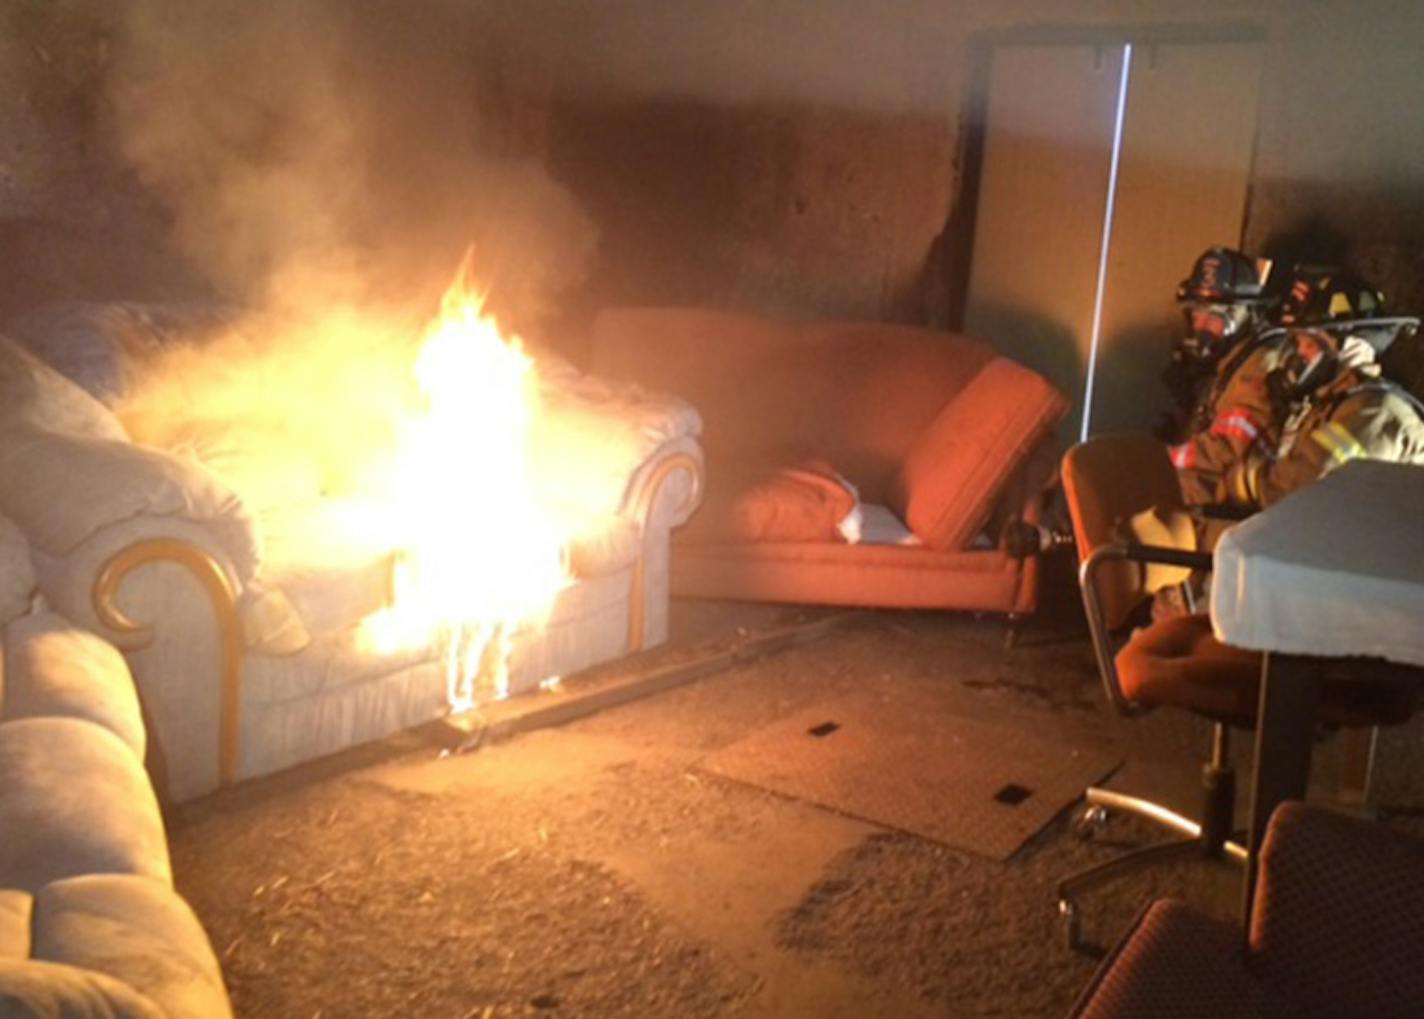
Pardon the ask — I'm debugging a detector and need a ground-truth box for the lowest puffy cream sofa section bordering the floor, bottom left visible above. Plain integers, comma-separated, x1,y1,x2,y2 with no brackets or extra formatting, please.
33,874,232,1019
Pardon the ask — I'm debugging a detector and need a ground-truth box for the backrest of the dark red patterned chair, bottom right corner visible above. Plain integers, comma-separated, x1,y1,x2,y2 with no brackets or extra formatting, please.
1250,803,1424,1016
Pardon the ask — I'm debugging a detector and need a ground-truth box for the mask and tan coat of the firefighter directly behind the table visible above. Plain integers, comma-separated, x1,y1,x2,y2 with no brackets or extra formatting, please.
1216,327,1424,510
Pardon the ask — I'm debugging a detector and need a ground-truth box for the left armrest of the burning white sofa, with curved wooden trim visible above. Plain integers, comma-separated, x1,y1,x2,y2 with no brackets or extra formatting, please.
0,424,261,794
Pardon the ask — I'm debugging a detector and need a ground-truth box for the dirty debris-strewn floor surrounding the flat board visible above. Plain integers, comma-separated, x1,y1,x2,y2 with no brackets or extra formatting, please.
172,580,1424,1019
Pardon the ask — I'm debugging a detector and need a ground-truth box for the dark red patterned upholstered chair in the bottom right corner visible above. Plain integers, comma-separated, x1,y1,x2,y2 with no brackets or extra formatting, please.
1072,803,1424,1019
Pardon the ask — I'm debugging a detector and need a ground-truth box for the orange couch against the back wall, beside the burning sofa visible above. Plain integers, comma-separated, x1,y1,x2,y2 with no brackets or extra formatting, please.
590,309,1068,613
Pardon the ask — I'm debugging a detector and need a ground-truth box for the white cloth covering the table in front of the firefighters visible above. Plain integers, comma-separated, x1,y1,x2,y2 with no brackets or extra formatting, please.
1210,460,1424,666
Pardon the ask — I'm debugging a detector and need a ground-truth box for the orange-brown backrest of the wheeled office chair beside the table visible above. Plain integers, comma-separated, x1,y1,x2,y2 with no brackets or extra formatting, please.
1062,434,1183,630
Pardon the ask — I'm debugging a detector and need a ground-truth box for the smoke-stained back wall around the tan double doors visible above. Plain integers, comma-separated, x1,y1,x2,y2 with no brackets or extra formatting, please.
11,0,1424,335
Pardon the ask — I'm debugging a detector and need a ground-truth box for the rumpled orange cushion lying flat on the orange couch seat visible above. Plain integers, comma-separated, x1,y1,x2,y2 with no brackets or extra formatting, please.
678,461,857,544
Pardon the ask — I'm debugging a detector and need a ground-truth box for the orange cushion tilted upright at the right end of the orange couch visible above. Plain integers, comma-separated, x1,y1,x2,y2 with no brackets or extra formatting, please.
887,357,1068,551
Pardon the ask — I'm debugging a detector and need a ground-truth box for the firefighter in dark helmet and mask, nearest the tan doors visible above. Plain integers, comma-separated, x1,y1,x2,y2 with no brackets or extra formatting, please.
1162,248,1270,441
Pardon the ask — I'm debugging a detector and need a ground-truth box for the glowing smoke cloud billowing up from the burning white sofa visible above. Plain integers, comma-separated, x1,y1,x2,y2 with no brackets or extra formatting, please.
86,0,597,504
